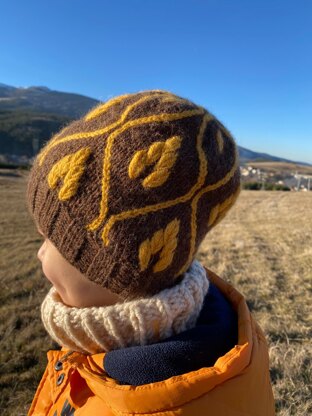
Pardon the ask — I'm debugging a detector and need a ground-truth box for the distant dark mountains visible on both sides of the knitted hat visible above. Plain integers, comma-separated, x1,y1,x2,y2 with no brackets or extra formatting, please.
0,83,309,166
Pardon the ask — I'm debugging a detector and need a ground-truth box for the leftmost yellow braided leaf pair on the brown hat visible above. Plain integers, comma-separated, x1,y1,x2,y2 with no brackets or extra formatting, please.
48,147,91,201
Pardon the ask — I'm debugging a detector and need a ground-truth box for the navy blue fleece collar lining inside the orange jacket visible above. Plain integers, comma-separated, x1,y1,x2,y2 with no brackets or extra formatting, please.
104,283,238,386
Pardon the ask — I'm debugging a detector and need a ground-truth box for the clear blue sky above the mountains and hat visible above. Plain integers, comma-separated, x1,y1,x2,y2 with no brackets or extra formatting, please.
0,0,312,163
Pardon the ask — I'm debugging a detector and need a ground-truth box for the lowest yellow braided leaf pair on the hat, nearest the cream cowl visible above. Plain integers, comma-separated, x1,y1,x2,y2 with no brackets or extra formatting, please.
139,218,180,273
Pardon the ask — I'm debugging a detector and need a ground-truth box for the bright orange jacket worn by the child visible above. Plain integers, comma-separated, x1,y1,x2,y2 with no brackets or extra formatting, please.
28,270,275,416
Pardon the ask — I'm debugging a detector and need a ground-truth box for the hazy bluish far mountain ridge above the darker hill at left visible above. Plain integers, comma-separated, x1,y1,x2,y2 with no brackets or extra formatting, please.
0,84,99,118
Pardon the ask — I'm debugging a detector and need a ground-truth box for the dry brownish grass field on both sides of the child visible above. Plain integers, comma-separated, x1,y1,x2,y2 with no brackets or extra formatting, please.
0,176,312,416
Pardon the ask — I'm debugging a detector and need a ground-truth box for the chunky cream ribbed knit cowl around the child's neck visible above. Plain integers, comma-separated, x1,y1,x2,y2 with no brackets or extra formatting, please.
41,260,209,354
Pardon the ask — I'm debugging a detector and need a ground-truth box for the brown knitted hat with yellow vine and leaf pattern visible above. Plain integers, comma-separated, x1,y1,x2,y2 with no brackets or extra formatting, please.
27,91,240,299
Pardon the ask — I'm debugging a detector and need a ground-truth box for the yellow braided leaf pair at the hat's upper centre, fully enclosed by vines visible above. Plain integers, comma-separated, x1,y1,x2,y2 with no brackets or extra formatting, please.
128,136,182,188
